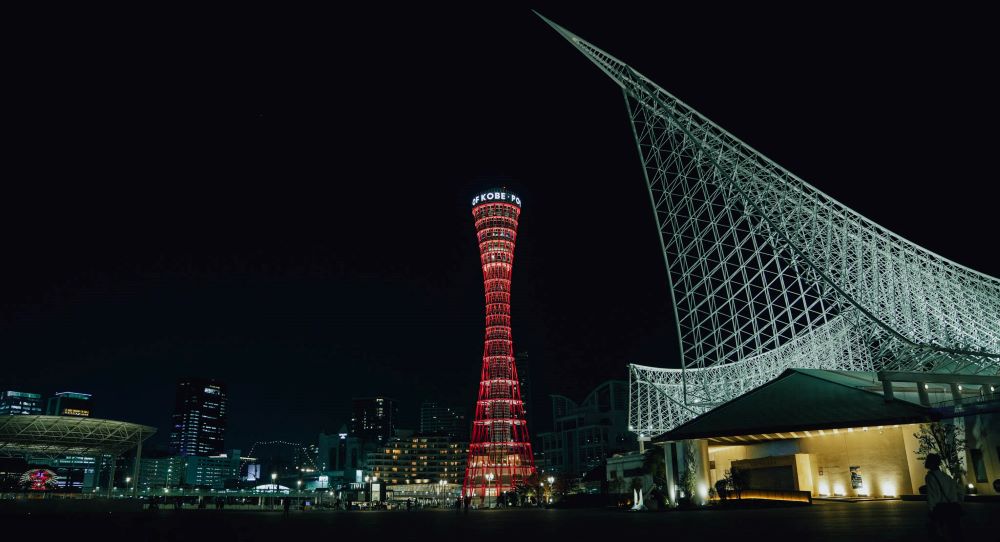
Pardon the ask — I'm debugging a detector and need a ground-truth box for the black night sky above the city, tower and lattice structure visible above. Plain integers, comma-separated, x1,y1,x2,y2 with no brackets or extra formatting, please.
0,4,1000,449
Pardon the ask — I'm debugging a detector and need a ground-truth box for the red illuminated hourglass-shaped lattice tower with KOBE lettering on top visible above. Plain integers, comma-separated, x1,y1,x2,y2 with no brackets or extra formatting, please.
462,190,535,502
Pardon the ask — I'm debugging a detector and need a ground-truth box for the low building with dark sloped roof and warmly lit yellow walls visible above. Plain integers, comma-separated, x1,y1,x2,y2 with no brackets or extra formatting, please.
654,369,1000,501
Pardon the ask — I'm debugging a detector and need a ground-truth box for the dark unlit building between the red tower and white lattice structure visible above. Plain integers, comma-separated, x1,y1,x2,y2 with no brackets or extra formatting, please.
539,380,638,477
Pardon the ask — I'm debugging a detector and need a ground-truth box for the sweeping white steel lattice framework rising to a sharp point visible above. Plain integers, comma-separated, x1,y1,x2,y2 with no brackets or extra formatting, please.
543,13,1000,435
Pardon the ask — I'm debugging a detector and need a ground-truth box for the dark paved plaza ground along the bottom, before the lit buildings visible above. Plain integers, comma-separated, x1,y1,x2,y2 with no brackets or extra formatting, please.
0,501,1000,542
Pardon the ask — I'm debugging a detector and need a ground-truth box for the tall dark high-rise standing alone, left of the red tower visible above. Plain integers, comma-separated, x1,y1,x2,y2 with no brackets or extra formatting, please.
170,378,226,456
